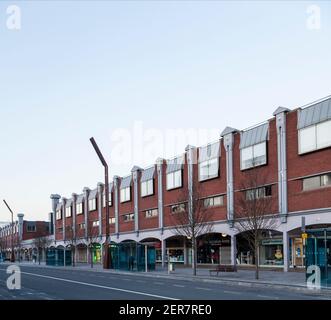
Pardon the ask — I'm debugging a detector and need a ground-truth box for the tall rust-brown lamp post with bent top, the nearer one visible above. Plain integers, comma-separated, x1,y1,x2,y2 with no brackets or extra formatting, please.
90,137,111,269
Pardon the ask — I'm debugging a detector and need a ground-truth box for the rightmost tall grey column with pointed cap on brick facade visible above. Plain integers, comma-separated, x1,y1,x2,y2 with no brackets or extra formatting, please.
273,107,289,223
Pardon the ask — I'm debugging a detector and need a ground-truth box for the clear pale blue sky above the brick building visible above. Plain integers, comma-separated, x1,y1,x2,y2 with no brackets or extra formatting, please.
0,0,331,221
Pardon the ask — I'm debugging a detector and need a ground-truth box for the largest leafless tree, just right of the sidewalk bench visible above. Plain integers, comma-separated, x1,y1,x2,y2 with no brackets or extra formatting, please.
234,168,278,279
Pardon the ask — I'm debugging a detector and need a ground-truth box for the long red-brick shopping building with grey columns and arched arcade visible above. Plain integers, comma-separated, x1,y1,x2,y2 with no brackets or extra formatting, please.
21,94,331,271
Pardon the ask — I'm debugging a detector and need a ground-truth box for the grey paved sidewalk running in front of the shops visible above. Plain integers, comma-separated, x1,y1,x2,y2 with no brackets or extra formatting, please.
10,262,307,289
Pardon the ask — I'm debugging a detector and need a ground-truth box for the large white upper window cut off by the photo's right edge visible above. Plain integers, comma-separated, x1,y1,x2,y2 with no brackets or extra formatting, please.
298,120,331,154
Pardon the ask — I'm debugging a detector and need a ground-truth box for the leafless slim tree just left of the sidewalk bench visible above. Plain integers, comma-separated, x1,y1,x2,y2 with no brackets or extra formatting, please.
168,185,214,276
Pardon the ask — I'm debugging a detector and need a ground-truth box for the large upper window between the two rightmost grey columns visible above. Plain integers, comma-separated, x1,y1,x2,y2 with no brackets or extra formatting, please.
240,142,267,170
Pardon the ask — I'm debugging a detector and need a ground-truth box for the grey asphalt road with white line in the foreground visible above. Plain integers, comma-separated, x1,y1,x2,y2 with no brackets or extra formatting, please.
0,265,331,300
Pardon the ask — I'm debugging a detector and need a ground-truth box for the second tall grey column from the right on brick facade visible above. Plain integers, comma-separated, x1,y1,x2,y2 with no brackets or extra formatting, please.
221,127,238,226
